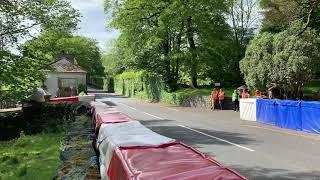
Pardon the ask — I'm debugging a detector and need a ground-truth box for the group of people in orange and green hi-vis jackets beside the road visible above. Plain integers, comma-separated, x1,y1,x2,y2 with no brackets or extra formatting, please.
211,88,267,111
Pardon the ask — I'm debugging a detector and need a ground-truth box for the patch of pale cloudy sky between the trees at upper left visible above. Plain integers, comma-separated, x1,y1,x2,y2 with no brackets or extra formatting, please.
71,0,119,49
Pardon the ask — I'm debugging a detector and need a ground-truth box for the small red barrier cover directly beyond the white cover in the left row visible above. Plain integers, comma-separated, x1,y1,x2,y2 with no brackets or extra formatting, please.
96,111,132,128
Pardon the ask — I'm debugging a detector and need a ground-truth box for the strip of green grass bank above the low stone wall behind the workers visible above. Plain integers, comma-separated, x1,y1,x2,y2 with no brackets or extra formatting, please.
175,88,234,97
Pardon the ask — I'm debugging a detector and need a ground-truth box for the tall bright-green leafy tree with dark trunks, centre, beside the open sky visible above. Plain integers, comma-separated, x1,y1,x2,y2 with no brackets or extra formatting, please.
106,0,232,90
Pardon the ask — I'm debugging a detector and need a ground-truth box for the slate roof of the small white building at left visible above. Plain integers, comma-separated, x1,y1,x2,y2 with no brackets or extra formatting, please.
49,56,87,73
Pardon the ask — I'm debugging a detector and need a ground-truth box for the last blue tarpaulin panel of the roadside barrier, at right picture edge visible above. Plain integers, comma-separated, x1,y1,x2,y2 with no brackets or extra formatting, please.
301,102,320,134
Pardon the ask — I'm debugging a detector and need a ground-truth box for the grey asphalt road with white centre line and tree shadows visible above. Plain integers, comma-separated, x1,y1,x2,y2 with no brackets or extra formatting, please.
97,95,320,180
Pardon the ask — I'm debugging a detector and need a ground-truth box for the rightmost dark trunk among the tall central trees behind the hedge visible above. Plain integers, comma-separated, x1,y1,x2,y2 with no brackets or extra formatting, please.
187,16,198,88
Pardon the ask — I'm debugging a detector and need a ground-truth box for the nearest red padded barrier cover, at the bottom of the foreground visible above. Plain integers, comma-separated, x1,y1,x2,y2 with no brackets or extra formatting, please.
107,143,246,180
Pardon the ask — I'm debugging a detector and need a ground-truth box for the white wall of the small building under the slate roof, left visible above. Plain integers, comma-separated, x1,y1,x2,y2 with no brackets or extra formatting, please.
44,72,87,97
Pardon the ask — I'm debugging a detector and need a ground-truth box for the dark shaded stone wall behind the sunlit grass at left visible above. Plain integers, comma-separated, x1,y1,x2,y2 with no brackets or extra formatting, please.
0,102,90,141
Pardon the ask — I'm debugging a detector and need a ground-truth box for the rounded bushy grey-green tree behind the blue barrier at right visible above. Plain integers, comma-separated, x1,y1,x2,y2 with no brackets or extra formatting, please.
240,22,320,97
